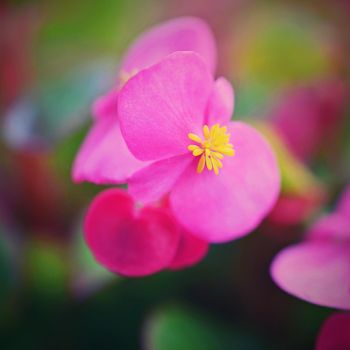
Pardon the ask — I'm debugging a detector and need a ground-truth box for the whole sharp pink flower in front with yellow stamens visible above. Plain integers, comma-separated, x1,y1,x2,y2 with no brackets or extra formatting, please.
118,52,280,242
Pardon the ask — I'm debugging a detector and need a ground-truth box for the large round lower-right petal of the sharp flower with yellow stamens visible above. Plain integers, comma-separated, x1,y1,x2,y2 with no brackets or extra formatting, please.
170,122,280,242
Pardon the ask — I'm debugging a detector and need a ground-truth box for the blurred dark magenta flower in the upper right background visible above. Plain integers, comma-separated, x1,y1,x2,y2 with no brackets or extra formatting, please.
272,80,345,160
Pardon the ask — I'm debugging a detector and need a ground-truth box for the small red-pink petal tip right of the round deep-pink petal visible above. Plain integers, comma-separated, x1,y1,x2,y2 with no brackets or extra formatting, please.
169,230,209,270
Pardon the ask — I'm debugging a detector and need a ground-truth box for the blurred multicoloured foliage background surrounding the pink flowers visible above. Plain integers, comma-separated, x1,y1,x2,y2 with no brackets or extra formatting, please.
0,0,350,350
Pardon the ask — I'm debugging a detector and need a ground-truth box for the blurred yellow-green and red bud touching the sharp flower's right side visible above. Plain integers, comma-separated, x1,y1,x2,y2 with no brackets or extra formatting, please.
255,122,326,226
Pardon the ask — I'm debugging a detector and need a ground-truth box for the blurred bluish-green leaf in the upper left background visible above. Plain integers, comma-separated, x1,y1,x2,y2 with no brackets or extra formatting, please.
2,62,114,150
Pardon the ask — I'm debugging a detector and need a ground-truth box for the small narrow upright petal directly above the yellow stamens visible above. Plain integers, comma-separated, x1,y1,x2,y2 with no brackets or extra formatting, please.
206,77,234,125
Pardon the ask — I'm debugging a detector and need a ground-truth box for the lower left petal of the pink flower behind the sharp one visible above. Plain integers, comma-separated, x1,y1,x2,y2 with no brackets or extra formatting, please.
73,117,147,184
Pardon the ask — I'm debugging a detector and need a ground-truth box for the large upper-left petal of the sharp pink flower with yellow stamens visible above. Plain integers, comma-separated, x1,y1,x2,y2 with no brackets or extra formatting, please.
118,52,213,160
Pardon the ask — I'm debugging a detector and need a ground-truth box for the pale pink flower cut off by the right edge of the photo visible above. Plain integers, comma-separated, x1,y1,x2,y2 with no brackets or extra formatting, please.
271,187,350,309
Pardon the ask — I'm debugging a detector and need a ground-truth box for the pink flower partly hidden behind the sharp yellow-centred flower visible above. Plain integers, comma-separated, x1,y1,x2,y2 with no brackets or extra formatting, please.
72,17,216,184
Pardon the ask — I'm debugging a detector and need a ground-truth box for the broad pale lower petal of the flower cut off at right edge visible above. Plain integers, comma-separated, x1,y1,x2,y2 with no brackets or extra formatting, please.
271,241,350,309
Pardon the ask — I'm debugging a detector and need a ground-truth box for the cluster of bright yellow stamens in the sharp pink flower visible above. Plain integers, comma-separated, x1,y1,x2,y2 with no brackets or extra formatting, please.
187,124,235,175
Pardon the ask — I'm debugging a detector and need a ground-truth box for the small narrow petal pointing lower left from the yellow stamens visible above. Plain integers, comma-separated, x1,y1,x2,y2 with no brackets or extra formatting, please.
128,154,193,204
